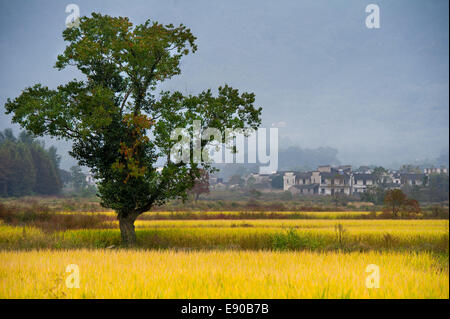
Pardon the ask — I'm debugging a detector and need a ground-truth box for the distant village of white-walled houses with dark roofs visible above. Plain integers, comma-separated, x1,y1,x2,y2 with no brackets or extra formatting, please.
210,165,448,195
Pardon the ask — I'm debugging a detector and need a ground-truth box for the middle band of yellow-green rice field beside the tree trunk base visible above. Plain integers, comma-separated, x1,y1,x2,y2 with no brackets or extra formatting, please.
0,220,449,254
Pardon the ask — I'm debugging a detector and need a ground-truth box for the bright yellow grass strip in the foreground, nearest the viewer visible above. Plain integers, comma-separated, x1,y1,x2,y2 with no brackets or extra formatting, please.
0,249,449,298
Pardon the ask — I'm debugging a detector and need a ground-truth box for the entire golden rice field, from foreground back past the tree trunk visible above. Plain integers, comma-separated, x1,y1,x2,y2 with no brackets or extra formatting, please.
0,212,449,298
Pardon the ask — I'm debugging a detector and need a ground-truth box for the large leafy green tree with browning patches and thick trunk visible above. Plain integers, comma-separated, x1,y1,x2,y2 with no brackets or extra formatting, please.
5,13,261,245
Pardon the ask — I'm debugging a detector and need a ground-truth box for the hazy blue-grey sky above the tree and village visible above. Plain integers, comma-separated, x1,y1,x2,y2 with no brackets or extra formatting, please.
0,0,449,169
